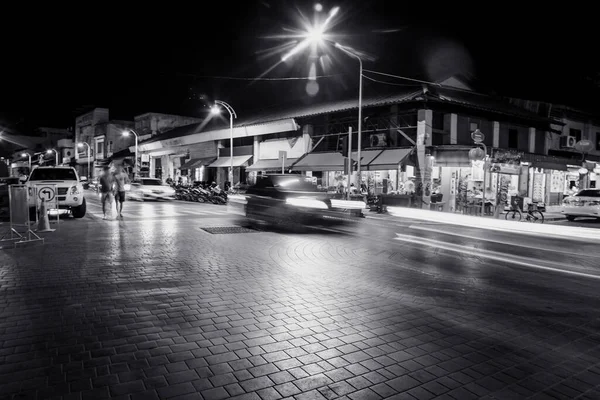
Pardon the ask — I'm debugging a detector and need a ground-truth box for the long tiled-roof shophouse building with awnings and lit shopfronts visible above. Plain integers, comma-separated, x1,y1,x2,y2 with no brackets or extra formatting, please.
134,78,554,216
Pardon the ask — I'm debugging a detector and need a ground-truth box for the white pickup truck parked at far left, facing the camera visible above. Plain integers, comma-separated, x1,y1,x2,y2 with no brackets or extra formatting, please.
27,166,86,218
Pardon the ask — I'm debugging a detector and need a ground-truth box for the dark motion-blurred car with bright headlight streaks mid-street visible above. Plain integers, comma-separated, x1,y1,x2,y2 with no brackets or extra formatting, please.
241,175,365,225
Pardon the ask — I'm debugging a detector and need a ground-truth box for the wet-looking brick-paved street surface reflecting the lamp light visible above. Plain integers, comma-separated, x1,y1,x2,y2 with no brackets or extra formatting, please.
0,192,600,400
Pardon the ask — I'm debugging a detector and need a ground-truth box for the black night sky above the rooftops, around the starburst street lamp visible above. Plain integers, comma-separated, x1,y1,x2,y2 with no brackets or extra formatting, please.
0,0,600,133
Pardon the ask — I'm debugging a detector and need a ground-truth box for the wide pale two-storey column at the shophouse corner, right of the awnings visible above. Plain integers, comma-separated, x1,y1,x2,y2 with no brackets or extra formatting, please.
415,110,433,208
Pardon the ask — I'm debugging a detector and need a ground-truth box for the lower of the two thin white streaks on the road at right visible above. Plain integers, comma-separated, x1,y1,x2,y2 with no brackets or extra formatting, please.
396,233,600,280
